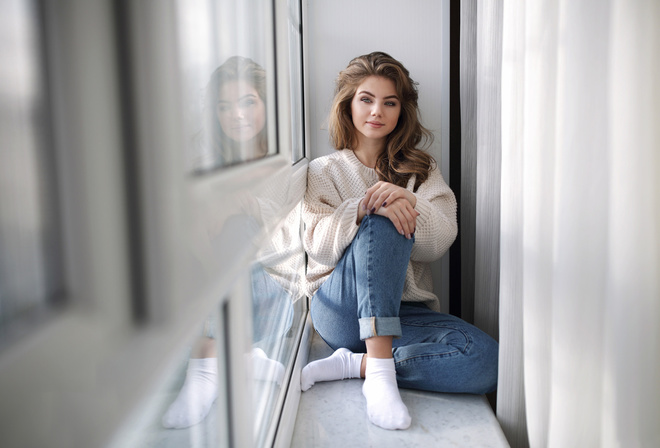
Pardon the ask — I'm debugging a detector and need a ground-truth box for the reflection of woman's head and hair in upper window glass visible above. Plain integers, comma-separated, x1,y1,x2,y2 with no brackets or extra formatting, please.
193,56,268,172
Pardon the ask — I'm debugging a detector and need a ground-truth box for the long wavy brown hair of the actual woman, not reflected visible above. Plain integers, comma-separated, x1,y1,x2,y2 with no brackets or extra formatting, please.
328,51,435,190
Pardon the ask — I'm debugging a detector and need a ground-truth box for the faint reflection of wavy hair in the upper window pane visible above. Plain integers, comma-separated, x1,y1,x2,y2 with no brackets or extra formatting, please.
204,56,268,165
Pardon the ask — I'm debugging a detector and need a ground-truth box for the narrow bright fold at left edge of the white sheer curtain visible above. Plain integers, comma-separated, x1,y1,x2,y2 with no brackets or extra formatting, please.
497,0,538,448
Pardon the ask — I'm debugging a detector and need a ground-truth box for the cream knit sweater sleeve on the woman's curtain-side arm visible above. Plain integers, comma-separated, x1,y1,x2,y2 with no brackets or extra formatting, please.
410,168,458,262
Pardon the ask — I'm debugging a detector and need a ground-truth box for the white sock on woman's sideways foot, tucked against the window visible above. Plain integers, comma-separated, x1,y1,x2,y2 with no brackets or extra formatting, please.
300,348,364,391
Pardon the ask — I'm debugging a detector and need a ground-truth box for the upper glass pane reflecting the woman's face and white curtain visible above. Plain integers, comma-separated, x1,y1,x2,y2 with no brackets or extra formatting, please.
177,0,277,173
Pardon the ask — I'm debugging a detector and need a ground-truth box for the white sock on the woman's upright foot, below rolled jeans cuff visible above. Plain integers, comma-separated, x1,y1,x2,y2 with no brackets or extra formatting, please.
362,358,411,429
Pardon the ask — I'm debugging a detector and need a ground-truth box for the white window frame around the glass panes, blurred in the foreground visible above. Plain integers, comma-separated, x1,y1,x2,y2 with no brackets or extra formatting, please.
0,0,307,447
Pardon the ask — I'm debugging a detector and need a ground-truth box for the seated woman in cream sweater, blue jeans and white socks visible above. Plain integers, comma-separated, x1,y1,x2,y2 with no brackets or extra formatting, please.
301,52,498,429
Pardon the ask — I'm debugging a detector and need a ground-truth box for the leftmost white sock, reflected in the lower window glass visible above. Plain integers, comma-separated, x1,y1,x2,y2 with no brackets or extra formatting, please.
162,358,218,429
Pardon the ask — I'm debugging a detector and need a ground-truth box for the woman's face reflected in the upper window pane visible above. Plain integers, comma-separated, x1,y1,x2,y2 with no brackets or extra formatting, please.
216,80,266,143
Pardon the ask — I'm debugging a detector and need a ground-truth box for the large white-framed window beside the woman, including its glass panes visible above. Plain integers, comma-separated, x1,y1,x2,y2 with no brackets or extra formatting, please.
0,0,307,447
